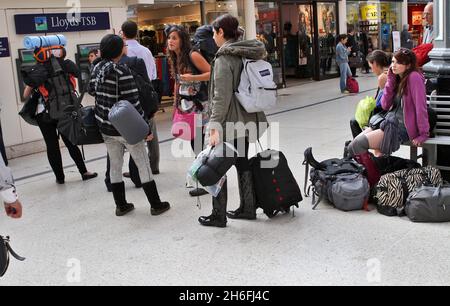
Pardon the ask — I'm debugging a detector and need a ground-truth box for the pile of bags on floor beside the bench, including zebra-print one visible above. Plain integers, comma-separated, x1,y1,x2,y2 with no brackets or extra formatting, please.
303,148,450,222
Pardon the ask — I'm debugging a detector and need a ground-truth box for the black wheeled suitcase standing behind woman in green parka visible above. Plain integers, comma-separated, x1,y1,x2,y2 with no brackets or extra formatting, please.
250,150,303,218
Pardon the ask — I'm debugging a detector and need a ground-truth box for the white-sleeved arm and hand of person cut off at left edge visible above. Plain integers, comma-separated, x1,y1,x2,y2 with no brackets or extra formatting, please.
0,155,22,219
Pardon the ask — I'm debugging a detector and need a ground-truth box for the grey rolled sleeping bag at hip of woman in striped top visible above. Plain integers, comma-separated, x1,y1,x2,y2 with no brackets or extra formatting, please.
108,100,150,145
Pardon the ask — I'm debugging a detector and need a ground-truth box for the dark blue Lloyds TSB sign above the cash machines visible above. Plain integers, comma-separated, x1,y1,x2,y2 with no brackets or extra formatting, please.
14,12,111,34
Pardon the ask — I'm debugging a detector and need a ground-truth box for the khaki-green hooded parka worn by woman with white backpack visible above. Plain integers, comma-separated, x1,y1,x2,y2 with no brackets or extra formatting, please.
206,39,268,143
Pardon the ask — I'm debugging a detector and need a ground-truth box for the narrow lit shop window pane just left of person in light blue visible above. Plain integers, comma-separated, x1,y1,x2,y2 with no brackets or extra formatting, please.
317,3,337,76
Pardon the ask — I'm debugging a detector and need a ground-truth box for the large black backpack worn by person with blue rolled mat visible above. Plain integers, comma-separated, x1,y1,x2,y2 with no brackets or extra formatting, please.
45,56,80,120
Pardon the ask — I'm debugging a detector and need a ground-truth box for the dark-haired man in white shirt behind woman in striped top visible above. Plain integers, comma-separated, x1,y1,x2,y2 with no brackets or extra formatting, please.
120,21,160,177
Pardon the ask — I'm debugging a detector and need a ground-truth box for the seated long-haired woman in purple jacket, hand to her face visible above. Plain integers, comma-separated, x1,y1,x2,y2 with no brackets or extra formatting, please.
347,48,430,156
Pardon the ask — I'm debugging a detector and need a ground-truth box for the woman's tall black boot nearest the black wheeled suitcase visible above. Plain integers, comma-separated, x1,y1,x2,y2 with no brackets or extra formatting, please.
227,171,256,220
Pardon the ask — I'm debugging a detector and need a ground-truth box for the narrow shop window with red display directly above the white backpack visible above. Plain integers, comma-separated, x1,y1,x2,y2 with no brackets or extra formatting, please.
255,2,283,84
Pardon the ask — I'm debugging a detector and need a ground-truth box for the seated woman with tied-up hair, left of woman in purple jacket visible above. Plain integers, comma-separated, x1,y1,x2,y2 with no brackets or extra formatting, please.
350,50,390,138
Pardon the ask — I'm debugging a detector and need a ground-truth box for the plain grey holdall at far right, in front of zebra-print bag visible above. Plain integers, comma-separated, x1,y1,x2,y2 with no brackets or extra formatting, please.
405,185,450,222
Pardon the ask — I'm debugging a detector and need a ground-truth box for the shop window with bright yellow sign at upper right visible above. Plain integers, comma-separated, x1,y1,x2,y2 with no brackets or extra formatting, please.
347,1,402,53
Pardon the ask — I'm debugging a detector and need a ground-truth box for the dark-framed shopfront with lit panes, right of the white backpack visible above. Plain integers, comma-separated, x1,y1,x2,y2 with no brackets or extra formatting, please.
281,1,338,80
